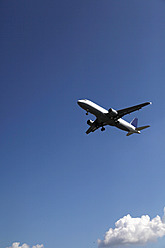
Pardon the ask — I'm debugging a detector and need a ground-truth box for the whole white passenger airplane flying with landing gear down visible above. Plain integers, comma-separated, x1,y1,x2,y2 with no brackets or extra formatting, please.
77,99,152,136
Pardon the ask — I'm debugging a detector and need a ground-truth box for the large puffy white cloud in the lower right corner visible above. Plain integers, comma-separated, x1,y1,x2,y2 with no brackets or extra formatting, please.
98,208,165,247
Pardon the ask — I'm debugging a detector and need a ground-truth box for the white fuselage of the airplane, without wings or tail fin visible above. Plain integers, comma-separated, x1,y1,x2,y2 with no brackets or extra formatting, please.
78,99,140,133
